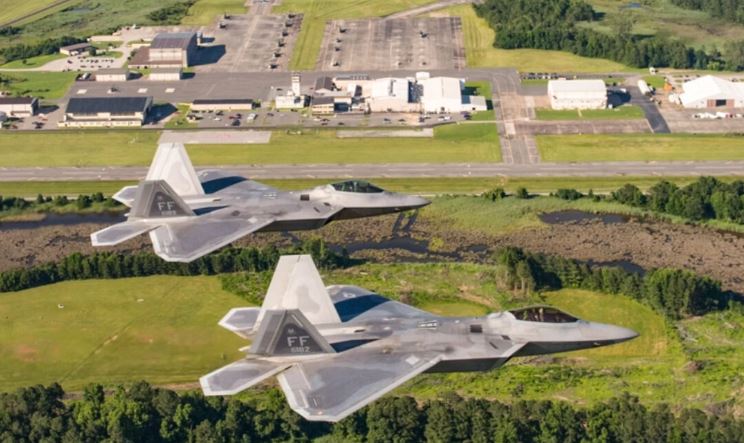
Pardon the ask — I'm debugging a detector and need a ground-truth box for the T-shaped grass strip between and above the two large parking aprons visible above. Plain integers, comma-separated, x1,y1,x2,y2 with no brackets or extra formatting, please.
273,0,436,71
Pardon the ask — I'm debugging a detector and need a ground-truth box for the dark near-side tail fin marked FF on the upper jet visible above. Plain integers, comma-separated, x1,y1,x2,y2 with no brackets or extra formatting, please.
129,180,194,218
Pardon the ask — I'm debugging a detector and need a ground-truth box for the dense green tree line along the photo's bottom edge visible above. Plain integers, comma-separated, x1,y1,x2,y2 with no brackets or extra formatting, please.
0,382,744,443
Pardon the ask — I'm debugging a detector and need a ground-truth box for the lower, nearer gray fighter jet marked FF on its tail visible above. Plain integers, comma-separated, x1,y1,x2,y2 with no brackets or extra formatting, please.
200,255,638,421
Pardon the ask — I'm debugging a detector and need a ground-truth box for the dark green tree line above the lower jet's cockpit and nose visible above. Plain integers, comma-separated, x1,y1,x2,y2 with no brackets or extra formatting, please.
495,247,740,320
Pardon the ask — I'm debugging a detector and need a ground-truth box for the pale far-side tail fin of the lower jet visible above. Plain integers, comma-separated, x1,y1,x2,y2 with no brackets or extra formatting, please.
256,255,341,327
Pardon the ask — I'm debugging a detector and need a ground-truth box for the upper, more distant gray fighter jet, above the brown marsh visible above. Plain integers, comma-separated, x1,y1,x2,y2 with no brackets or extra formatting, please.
91,143,429,262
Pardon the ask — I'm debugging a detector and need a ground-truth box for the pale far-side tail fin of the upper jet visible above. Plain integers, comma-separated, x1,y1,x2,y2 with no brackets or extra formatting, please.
145,143,204,195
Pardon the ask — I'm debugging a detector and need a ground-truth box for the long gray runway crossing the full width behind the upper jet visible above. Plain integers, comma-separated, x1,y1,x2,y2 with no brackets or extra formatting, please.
5,161,744,181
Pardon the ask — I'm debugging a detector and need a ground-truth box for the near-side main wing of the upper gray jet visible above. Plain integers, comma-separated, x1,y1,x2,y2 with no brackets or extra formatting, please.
150,213,274,262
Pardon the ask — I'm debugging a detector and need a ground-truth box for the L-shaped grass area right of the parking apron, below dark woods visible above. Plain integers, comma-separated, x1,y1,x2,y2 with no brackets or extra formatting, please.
442,5,631,72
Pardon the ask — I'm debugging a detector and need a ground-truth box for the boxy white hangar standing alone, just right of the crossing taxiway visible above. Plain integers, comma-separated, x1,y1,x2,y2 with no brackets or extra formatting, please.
548,79,607,109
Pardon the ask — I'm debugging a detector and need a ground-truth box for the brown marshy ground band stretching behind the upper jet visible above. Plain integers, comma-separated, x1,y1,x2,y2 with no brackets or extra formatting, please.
0,215,744,293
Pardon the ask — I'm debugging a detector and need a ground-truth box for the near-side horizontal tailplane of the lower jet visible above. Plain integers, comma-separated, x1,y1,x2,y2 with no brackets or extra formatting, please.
199,360,291,395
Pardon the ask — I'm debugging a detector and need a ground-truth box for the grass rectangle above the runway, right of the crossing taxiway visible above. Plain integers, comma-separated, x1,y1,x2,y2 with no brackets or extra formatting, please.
537,134,744,162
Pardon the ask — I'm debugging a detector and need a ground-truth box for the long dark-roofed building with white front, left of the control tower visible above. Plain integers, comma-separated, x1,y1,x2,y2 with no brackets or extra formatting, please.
59,97,152,128
